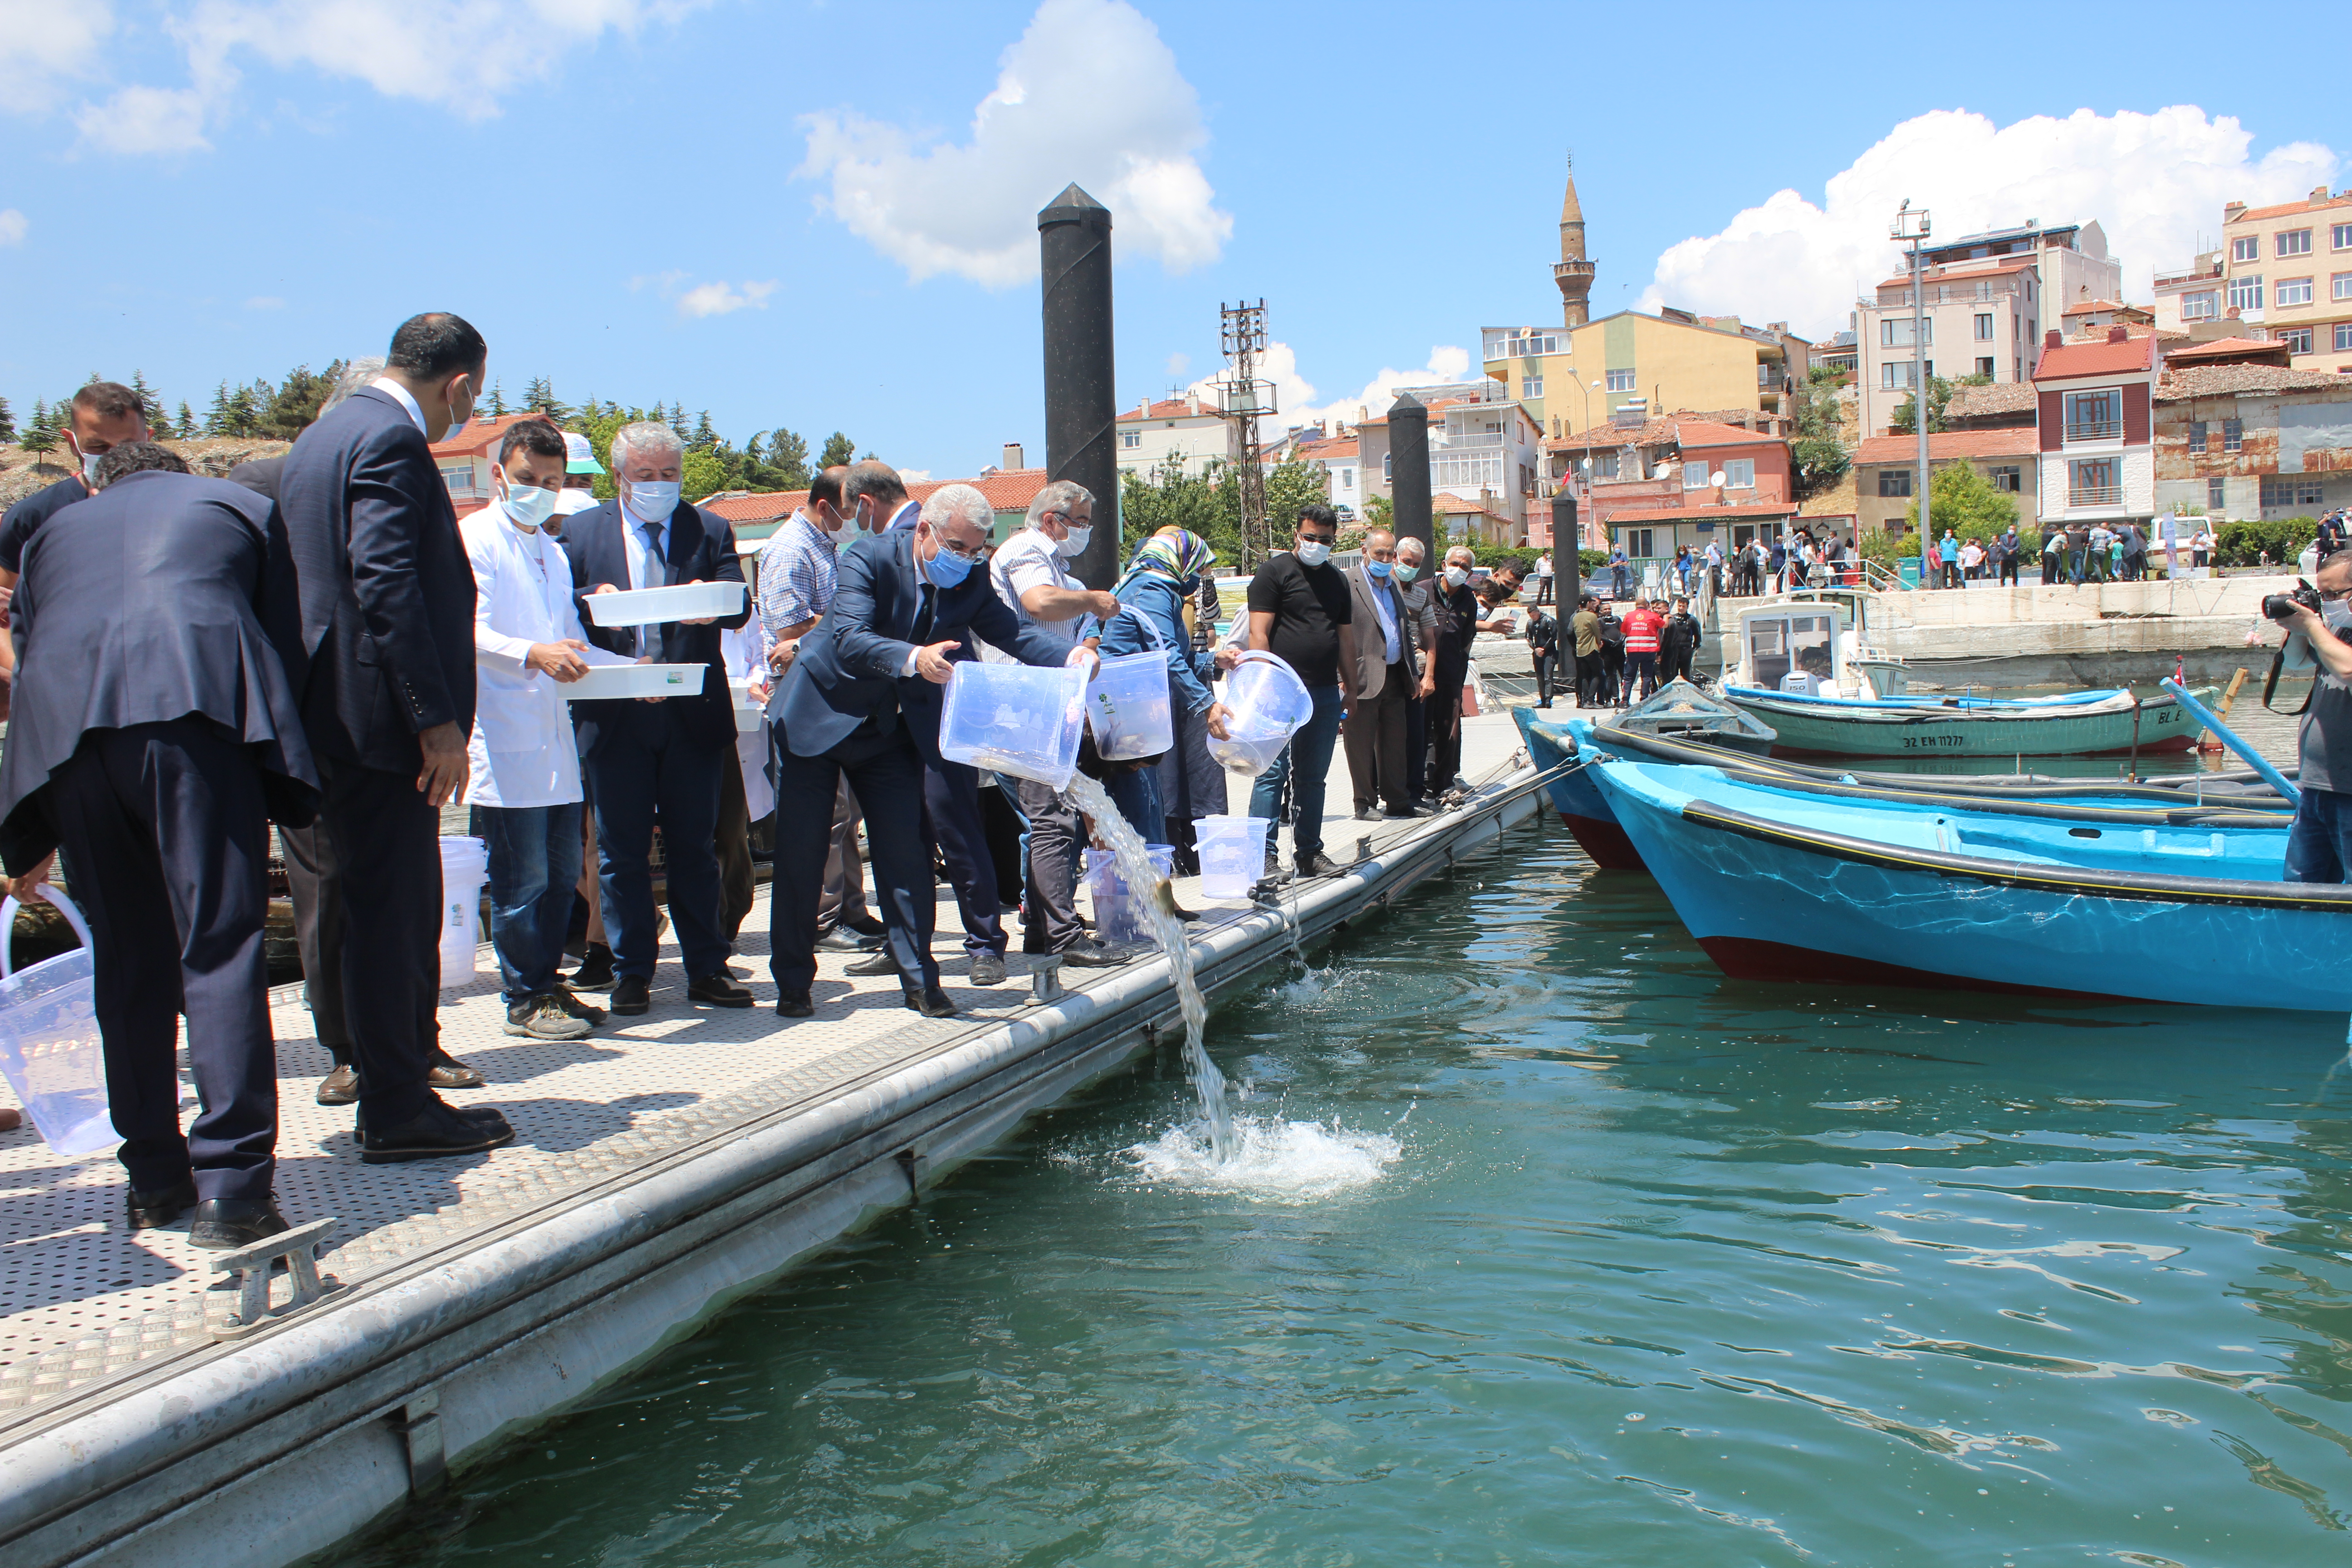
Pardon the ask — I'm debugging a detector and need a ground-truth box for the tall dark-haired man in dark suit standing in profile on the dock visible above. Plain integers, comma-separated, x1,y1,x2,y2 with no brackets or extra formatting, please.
278,313,515,1164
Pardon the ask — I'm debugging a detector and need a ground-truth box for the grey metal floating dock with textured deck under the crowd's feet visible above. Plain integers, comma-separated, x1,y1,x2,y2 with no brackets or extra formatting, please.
0,712,1541,1568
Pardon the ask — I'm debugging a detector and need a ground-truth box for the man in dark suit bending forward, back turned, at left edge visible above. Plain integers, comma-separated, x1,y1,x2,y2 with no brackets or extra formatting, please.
0,442,318,1248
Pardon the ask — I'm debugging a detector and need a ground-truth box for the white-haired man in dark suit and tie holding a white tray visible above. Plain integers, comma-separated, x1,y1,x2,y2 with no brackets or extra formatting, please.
564,421,752,1013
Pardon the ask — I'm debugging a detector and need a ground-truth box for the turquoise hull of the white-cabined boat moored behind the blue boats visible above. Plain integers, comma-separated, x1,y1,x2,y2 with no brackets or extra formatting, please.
1731,694,2201,757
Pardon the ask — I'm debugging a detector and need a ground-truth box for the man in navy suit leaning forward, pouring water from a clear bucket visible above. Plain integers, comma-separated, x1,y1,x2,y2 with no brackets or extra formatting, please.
767,484,1091,1018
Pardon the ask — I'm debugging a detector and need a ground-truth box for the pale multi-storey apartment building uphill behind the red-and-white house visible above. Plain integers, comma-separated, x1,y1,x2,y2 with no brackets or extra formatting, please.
1856,221,2124,435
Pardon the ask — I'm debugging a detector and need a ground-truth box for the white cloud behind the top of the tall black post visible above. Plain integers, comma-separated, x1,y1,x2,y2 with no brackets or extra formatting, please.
797,0,1232,289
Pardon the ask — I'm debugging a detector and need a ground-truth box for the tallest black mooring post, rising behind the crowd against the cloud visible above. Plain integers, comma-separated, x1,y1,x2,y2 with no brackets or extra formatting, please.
1037,186,1124,588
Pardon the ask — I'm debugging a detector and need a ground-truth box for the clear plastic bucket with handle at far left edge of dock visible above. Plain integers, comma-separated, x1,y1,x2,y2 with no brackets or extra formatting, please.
0,886,122,1159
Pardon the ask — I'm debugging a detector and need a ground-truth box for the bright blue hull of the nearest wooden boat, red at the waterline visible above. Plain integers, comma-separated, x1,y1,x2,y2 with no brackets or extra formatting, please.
1590,764,2352,1011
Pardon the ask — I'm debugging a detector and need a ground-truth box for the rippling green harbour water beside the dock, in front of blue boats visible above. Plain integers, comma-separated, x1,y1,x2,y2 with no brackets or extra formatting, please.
355,828,2352,1568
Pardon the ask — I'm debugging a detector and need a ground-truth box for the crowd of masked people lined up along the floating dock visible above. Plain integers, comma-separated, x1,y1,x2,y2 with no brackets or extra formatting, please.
0,313,1548,1248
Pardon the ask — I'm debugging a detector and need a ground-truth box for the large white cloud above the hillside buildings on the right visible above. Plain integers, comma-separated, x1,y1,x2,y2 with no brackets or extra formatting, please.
1637,103,2340,334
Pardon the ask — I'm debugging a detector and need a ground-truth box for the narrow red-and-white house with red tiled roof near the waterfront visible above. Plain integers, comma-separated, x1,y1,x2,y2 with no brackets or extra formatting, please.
2032,324,2159,529
